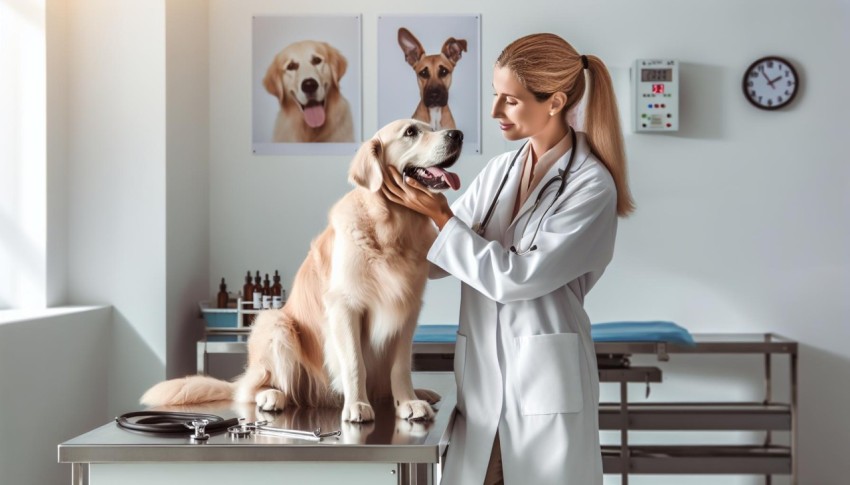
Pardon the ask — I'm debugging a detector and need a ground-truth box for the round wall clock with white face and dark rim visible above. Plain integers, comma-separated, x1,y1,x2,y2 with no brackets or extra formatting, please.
744,56,798,110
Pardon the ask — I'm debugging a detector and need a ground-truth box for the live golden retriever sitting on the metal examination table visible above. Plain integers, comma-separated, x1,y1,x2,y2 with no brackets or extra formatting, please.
141,119,463,422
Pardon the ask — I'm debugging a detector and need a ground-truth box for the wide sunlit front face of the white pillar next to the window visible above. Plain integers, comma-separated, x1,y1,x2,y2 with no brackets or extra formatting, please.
66,0,167,414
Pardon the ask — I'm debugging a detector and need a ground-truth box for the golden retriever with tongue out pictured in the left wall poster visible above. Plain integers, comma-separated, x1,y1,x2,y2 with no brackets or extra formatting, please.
263,40,354,143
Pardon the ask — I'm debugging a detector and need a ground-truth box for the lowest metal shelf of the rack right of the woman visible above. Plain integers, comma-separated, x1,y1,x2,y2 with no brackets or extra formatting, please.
602,445,792,475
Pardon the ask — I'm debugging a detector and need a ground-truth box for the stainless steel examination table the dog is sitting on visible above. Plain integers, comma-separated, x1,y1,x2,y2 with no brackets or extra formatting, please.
59,372,456,485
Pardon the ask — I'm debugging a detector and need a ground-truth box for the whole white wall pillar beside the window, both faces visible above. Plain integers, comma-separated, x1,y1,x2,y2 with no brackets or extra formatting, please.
61,0,209,412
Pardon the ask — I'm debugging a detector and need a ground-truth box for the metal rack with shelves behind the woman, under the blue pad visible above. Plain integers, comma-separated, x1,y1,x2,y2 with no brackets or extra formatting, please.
414,333,798,485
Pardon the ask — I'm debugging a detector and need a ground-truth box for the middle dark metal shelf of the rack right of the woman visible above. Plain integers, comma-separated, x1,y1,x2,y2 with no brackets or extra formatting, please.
599,402,791,431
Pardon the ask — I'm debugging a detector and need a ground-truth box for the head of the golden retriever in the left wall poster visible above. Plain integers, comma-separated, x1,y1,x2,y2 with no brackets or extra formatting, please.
263,40,348,128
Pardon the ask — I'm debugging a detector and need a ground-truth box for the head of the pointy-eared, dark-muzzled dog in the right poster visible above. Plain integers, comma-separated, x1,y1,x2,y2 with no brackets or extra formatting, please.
398,27,466,108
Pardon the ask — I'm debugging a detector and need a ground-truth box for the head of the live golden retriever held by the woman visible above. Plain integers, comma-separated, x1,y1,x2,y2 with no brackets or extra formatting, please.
348,120,463,192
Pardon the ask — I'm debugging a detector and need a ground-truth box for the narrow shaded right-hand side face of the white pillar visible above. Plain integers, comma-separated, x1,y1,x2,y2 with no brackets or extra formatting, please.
165,0,210,377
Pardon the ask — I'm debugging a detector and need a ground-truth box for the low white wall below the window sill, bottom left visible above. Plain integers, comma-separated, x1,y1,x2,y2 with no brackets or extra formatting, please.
0,307,112,485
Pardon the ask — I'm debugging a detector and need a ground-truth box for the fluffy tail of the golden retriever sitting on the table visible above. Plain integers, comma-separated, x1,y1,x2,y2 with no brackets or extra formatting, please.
139,376,234,406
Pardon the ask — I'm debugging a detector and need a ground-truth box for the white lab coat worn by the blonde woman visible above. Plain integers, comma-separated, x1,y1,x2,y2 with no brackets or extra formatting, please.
428,133,617,485
